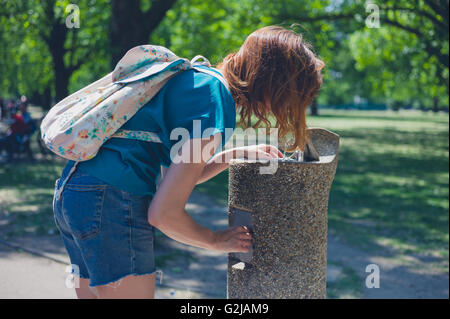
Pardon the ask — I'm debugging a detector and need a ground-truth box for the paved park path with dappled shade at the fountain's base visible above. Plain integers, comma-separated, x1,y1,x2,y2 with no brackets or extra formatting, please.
0,192,449,298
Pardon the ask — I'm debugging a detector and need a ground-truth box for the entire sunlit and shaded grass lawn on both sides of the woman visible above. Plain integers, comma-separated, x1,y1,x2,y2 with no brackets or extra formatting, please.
0,110,449,258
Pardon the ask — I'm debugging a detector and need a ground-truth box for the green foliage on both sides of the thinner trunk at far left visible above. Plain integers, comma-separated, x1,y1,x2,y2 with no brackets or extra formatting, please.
0,0,109,102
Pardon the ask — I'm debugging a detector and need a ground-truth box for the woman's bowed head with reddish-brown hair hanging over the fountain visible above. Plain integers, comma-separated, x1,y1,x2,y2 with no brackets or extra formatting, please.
219,26,324,150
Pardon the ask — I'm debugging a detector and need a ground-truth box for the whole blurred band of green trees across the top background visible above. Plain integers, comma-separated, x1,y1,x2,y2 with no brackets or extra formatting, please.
0,0,449,111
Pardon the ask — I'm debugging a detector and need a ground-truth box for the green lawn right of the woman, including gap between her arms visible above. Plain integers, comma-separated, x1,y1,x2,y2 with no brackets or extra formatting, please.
196,110,449,258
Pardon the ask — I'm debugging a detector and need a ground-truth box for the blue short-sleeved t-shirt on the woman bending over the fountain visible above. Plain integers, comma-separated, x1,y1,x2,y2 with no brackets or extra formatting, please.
67,66,236,196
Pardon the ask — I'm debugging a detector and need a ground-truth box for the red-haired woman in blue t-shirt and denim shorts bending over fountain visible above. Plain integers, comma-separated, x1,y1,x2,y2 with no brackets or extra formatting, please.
53,26,324,298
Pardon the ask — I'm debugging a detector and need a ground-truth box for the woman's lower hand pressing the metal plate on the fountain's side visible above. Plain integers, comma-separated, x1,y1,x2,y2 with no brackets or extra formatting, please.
211,226,252,253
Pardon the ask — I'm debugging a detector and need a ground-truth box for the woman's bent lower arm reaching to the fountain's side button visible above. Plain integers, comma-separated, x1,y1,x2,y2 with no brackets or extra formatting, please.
148,133,251,252
